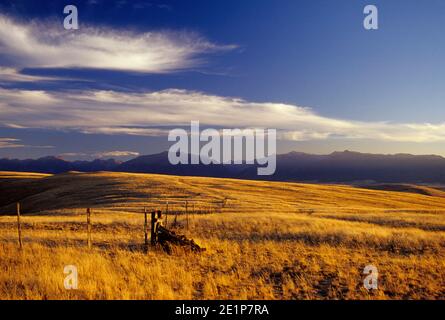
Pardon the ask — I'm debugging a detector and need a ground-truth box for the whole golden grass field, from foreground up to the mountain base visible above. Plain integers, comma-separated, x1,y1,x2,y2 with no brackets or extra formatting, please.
0,172,445,299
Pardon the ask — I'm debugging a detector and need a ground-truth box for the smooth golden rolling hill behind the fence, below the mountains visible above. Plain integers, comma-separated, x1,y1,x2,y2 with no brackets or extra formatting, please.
0,172,445,214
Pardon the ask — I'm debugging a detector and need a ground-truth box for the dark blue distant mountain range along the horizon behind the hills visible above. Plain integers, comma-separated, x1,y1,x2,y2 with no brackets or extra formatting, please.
0,151,445,183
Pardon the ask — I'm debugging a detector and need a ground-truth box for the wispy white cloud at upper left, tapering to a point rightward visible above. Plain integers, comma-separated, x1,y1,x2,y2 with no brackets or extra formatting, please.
0,15,236,73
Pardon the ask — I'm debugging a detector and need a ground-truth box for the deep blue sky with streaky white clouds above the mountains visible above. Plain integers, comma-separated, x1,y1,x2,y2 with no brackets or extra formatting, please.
0,0,445,159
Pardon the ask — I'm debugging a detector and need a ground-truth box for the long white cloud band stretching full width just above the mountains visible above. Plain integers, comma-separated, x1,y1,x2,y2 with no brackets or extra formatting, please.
0,89,445,142
